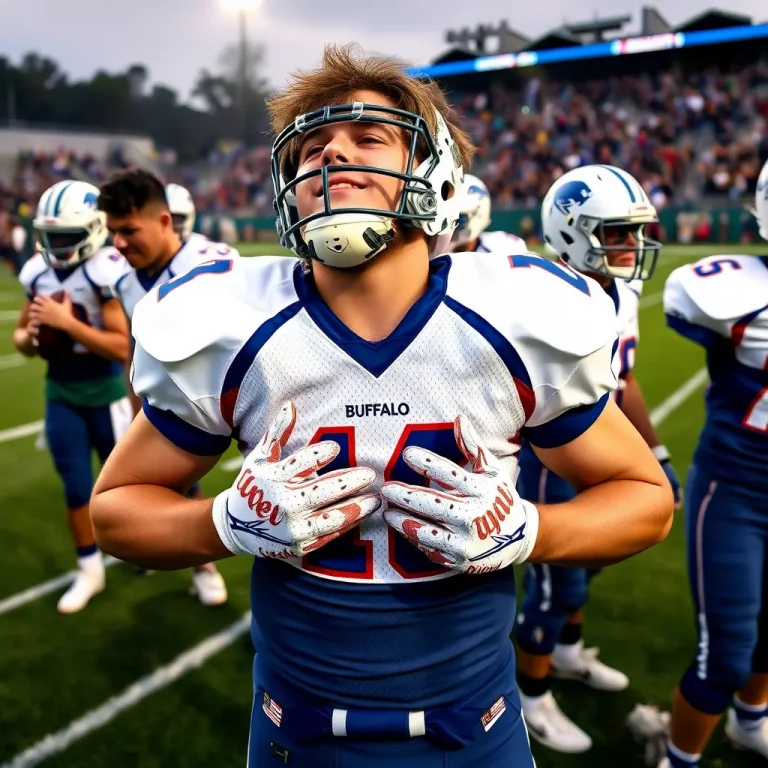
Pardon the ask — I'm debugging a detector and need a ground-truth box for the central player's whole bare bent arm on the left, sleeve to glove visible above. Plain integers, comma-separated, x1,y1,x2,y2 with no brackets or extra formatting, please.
90,413,232,570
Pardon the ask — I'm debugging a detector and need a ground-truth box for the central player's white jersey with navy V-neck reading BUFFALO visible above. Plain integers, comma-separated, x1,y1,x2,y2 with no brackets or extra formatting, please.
132,253,618,583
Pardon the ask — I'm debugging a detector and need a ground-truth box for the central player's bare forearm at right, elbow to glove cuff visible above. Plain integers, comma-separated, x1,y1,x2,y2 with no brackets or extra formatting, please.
530,474,673,568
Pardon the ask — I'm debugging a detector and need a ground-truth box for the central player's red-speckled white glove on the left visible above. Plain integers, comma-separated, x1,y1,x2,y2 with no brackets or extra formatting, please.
213,403,382,560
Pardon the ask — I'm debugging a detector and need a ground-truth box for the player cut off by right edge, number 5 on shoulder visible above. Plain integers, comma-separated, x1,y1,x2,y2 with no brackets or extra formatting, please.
662,163,768,768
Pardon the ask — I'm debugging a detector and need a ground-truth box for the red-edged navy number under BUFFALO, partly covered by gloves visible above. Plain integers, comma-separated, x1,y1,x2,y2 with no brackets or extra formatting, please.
302,422,466,579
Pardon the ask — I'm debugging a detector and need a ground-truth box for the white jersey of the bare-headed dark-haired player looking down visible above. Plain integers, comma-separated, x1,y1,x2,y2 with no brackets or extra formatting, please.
113,234,240,320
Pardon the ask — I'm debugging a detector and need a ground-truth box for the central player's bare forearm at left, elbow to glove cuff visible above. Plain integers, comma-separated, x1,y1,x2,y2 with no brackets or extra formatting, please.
90,485,232,570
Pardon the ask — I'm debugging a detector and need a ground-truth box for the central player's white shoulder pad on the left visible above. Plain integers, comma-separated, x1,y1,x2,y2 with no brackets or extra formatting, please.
132,257,297,363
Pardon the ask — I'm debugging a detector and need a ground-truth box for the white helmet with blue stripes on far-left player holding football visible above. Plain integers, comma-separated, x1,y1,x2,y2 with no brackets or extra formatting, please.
32,180,109,269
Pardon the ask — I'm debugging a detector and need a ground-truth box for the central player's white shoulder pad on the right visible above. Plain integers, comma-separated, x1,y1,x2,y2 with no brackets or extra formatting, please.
448,253,616,357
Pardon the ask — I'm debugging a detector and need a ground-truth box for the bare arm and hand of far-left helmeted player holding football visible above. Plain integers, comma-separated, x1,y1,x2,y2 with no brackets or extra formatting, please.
30,296,129,363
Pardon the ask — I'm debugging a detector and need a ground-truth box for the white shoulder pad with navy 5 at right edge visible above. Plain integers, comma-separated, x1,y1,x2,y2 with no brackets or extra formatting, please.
665,255,768,321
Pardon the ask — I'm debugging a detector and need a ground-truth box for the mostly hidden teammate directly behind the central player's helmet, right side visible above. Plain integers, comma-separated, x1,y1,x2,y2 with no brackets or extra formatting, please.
451,173,528,256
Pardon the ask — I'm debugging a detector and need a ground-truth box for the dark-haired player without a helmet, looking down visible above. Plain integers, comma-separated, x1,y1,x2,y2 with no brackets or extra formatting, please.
99,168,238,606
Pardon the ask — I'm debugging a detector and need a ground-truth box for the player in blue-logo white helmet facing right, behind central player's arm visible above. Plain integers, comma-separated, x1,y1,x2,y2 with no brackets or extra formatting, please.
516,165,680,752
